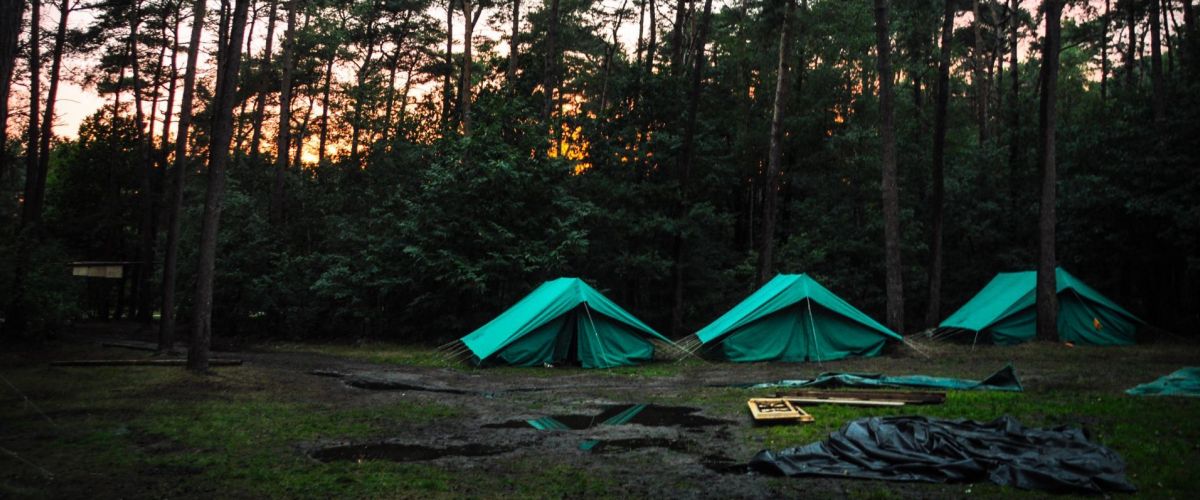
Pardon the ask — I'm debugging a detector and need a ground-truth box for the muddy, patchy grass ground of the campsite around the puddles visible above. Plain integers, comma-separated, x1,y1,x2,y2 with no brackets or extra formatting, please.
0,328,1200,498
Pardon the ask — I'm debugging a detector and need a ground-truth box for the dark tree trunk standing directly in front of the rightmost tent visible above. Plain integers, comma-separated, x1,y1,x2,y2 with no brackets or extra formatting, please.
1037,0,1062,342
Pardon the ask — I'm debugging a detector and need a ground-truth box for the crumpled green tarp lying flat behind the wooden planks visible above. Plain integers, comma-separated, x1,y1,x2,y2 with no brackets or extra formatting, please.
750,365,1022,392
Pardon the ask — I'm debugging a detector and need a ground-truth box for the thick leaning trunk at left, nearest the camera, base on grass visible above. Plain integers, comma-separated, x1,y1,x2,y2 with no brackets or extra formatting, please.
187,0,250,373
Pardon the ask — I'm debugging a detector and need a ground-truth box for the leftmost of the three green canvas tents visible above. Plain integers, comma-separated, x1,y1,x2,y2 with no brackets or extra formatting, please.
460,278,671,368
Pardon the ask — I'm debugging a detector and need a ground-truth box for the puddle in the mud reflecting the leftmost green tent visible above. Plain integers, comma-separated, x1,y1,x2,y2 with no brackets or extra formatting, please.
484,404,733,430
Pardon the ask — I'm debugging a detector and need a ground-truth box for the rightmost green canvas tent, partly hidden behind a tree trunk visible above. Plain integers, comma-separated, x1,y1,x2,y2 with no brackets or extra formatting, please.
938,267,1145,345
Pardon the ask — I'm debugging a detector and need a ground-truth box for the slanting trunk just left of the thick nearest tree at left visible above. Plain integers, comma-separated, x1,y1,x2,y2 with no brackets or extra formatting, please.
158,0,208,353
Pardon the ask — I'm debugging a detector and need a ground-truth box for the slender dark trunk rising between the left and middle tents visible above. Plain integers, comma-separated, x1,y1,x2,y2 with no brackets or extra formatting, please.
672,0,713,336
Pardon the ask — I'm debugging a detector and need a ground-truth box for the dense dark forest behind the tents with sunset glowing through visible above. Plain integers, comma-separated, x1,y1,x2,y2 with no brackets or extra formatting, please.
0,0,1200,357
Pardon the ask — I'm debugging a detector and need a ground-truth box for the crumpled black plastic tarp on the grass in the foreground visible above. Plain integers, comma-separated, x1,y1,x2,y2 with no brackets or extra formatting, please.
750,416,1136,493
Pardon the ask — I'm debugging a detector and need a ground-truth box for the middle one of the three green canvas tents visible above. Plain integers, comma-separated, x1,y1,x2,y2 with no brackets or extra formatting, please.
692,275,901,362
